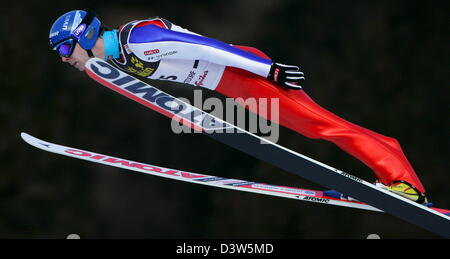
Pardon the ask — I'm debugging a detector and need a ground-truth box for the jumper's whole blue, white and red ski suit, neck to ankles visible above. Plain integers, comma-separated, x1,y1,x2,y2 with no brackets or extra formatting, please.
110,18,425,193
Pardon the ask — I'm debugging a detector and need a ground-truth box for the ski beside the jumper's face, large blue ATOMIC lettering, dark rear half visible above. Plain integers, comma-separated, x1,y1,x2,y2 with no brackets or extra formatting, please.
79,58,450,238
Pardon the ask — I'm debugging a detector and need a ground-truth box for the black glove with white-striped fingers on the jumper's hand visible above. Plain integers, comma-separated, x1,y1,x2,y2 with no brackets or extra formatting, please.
267,63,305,90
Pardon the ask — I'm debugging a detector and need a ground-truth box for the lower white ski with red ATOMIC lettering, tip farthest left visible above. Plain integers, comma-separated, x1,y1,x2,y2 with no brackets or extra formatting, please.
21,132,450,215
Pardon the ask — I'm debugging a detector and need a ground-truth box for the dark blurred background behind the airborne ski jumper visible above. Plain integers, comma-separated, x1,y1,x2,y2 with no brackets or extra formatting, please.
0,0,450,238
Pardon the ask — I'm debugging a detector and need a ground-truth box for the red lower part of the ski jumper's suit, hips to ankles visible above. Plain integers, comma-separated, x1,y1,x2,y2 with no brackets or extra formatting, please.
215,46,425,193
